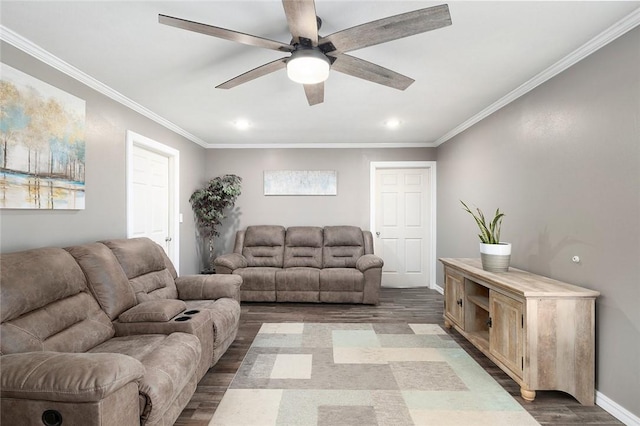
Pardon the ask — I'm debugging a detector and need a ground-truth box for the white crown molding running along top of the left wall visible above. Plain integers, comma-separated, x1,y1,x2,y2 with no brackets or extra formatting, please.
0,25,208,148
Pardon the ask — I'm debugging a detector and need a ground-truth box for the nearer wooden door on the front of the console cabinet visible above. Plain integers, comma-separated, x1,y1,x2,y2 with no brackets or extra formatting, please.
489,291,524,377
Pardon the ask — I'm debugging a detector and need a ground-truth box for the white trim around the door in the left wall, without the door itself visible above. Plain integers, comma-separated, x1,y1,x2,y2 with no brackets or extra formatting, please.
126,130,180,274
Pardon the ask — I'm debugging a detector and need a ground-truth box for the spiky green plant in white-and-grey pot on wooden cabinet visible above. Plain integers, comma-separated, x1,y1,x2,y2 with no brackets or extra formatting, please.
460,200,511,272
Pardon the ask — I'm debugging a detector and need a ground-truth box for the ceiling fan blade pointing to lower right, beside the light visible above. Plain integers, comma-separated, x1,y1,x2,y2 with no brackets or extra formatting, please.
331,54,415,90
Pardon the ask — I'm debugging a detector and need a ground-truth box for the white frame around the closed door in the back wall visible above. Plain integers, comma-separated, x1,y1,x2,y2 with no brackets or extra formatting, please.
369,161,437,289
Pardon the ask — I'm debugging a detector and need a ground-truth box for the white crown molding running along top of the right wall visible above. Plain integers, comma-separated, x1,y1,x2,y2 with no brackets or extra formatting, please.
434,8,640,146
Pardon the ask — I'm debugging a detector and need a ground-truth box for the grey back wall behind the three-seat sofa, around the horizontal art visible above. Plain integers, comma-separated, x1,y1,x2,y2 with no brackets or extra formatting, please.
207,148,435,258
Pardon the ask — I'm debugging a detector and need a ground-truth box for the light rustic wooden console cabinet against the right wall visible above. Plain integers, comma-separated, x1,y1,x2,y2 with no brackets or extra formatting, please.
440,258,600,405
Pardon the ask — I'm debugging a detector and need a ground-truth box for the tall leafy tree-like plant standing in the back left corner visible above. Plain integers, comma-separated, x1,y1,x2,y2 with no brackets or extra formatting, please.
189,174,242,273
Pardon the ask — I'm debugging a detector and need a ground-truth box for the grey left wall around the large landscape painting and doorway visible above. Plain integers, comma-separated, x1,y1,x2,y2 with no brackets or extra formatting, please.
0,43,205,274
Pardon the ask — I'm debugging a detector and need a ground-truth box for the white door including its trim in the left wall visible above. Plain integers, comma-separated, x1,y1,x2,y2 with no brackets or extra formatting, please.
127,132,179,268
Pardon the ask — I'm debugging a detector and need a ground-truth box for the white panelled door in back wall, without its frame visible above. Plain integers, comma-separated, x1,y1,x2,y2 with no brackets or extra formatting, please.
374,168,431,287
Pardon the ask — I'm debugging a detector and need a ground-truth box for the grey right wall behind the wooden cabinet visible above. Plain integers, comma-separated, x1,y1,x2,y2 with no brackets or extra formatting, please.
437,29,640,415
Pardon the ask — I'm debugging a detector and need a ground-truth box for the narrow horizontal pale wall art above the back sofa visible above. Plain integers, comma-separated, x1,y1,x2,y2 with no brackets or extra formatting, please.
264,170,338,195
